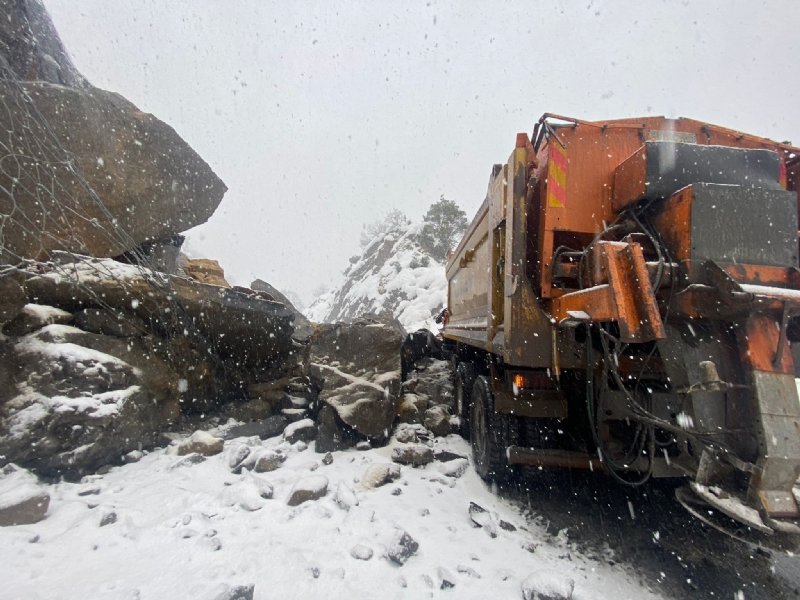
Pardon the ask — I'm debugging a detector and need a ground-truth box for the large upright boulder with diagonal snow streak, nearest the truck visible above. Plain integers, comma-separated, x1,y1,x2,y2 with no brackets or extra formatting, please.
310,317,405,442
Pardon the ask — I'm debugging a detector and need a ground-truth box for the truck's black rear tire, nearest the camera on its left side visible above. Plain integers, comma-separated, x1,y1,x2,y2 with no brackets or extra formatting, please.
470,375,519,483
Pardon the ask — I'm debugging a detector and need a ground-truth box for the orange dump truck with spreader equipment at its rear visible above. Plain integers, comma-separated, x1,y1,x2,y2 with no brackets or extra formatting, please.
443,114,800,543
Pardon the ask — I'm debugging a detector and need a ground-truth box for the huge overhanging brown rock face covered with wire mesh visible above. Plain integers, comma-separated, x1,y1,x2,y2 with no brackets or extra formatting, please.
0,0,226,263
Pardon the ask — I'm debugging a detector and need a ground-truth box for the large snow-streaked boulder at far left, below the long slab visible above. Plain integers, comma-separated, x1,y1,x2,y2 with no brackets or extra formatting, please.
0,325,180,475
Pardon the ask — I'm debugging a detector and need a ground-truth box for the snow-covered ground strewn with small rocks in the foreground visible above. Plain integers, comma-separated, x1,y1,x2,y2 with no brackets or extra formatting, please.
0,428,658,600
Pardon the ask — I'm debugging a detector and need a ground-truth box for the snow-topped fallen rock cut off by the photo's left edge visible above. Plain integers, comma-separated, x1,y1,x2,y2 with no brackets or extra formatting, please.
0,464,50,527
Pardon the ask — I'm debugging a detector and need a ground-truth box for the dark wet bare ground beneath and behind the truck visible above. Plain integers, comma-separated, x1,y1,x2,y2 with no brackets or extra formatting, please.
499,469,800,600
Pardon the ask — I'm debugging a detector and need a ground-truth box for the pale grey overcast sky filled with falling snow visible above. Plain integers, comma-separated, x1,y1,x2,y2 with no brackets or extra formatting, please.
45,0,800,302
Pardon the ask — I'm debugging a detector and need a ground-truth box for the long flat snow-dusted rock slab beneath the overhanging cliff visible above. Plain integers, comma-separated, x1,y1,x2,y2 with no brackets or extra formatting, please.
25,252,293,377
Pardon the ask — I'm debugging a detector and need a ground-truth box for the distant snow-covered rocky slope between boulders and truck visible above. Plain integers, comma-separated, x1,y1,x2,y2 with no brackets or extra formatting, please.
306,225,447,331
